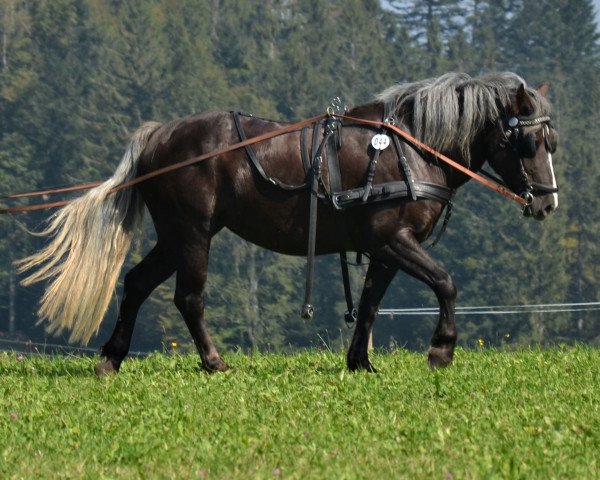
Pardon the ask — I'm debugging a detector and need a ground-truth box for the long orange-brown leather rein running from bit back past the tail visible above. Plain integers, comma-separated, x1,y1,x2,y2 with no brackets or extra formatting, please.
0,112,528,214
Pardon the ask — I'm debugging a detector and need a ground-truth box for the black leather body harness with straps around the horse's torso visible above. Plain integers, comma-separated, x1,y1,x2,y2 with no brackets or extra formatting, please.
232,103,454,325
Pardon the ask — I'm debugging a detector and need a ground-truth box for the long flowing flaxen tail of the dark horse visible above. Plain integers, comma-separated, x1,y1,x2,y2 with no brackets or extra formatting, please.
18,122,160,344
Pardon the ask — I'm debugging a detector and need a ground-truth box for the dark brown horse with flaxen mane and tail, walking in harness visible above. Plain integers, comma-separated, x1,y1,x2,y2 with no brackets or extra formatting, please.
20,72,558,375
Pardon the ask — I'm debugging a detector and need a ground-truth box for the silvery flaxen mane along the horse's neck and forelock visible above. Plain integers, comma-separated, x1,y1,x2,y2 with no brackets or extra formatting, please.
377,72,549,161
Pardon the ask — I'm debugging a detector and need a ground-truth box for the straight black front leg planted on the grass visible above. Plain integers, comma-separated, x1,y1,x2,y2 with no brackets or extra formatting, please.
346,260,396,372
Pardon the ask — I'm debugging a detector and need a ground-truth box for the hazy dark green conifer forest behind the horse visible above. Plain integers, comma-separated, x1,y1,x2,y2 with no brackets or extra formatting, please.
0,0,600,351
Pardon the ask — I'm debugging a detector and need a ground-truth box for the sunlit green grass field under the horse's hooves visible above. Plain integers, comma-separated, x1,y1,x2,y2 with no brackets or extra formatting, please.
0,346,600,480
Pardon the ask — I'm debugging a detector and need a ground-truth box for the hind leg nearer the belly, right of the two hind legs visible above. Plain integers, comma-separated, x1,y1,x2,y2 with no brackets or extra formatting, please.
175,244,228,372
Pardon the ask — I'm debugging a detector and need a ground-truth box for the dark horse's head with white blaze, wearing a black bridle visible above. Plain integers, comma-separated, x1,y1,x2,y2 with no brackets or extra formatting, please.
488,84,558,220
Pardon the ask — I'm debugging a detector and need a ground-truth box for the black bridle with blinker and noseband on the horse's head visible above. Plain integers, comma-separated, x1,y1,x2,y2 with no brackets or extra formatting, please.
504,115,558,205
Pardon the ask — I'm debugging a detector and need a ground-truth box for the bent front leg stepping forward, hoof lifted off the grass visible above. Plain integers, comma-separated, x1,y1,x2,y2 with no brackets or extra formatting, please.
378,229,457,368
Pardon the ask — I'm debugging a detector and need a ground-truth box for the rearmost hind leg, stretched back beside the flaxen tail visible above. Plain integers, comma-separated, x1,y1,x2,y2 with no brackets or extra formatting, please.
96,243,175,376
